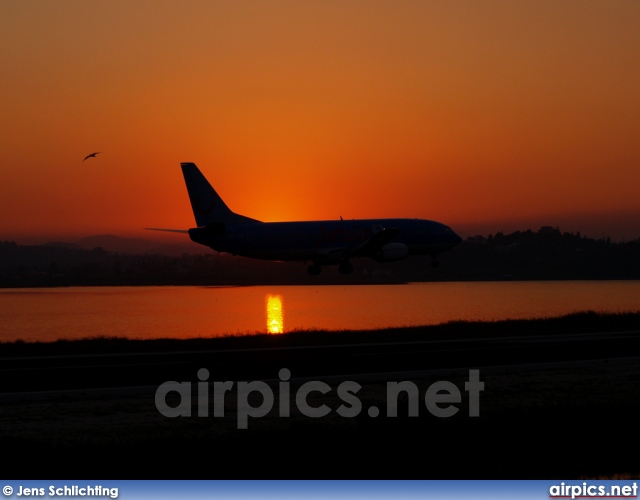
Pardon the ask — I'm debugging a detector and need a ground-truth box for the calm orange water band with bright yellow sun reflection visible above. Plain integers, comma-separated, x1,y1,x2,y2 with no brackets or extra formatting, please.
0,281,640,341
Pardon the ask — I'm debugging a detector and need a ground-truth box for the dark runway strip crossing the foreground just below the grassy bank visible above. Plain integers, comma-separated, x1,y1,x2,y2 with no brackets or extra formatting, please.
0,331,640,394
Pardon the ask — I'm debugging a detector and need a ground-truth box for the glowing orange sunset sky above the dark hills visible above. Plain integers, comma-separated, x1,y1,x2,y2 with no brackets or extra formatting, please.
0,0,640,243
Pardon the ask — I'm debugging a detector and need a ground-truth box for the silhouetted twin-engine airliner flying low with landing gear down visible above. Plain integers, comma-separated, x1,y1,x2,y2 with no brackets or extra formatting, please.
145,162,462,276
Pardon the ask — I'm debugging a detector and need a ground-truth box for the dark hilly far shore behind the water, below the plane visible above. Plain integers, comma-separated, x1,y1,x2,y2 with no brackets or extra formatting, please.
0,227,640,288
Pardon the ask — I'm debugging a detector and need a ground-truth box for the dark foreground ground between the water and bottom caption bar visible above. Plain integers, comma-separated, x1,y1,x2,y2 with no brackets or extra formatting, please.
0,313,640,479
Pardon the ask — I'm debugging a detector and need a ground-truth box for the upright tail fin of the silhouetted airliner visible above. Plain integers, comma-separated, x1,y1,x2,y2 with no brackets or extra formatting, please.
180,162,260,227
